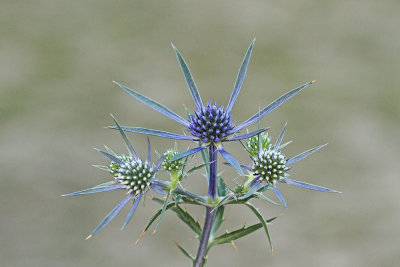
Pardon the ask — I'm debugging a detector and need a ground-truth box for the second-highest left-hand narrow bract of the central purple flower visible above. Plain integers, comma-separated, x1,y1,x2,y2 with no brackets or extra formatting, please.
114,82,189,127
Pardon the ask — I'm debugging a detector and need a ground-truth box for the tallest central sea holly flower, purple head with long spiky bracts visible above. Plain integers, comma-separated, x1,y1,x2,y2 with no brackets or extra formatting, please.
110,40,314,175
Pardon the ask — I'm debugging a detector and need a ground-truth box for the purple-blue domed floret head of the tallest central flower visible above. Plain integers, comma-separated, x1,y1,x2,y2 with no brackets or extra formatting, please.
188,103,233,143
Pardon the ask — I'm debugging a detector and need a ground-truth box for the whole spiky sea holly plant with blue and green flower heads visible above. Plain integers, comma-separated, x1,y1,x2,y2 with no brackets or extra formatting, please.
65,40,338,267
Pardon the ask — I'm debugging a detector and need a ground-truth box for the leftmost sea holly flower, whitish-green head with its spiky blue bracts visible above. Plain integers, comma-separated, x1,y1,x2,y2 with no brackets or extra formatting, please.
64,117,166,239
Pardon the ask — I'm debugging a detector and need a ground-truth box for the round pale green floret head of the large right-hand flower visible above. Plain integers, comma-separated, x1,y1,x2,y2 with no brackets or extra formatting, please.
252,149,289,184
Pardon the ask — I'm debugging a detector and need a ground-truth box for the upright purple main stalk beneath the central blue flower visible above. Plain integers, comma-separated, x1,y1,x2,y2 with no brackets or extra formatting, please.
193,145,217,267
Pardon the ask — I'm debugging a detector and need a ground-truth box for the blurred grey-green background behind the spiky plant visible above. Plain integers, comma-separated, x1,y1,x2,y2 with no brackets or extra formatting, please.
0,0,400,266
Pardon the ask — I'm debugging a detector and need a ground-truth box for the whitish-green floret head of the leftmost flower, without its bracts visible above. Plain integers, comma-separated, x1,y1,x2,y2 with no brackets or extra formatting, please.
109,156,154,196
